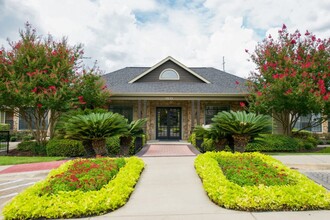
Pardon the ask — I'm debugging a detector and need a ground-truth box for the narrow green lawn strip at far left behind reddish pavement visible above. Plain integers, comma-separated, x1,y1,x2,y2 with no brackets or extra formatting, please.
0,156,65,166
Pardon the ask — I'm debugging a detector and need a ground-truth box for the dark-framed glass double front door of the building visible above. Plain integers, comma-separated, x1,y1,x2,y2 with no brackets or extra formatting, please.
156,107,181,140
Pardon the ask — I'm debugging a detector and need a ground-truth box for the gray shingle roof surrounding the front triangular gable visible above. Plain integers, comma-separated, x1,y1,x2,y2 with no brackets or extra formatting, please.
103,67,246,95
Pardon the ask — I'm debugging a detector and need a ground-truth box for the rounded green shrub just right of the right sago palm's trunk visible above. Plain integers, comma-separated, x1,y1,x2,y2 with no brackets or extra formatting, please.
246,134,299,152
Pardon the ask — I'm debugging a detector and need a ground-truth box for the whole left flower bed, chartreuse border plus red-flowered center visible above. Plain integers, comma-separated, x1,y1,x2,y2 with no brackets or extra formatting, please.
3,157,144,219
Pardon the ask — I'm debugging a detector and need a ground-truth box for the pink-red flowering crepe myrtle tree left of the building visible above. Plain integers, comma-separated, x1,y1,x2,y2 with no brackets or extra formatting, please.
0,23,108,144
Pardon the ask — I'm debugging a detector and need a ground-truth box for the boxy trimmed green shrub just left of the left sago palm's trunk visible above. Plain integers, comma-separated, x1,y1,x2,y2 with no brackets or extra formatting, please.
46,139,86,157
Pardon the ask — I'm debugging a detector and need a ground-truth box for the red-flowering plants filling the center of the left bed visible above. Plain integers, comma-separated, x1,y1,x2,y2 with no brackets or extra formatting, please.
42,158,126,195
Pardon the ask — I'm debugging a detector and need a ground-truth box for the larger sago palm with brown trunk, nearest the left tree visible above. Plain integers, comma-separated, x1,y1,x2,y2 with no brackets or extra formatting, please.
63,112,127,155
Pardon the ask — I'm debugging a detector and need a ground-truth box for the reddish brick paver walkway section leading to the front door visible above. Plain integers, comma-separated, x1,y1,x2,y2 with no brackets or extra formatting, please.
138,144,198,157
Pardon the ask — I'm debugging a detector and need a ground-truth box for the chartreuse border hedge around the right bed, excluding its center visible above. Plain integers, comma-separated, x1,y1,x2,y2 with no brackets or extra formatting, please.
195,152,330,211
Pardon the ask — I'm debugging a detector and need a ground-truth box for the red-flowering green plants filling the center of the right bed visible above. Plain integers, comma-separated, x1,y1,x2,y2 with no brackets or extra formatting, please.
218,154,294,186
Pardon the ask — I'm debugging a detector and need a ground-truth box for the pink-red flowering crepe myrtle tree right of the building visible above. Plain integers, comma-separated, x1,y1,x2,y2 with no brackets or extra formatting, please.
246,25,330,135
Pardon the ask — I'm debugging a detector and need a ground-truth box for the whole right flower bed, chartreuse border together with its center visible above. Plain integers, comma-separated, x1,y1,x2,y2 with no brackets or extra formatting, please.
195,152,330,211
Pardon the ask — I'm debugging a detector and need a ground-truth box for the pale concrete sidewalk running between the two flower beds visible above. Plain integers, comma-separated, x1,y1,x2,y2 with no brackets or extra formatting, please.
90,157,330,220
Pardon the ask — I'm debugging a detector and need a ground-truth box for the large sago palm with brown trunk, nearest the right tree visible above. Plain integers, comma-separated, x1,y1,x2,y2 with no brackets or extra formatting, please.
212,111,272,152
